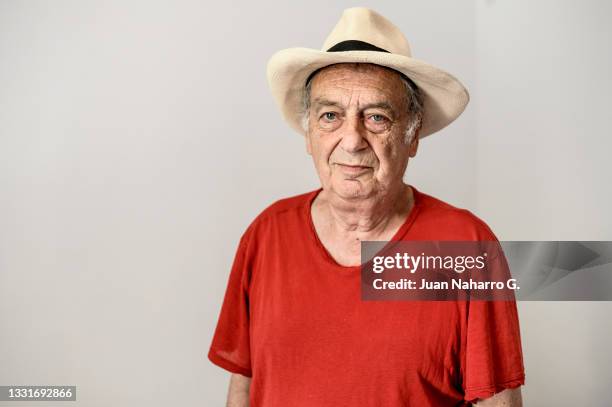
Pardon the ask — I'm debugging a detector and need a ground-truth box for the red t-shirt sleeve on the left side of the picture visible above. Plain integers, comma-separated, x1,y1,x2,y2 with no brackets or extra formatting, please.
208,234,252,377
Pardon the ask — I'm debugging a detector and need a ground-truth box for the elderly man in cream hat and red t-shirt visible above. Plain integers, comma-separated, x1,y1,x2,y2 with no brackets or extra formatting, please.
208,8,524,407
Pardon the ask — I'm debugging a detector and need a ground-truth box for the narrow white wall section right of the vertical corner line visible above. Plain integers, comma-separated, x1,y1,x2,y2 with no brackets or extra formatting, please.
474,0,612,406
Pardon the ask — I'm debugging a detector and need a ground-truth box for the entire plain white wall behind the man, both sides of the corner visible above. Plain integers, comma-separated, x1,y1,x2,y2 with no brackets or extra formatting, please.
0,0,612,407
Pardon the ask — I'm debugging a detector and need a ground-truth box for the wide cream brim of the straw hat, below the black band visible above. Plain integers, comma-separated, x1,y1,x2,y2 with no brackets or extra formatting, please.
267,48,470,138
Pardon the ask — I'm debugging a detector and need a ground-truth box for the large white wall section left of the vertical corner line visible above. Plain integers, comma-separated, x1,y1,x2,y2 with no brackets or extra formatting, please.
0,0,476,407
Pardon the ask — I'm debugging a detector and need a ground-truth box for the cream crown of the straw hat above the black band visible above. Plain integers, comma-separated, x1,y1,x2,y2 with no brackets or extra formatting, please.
321,7,412,57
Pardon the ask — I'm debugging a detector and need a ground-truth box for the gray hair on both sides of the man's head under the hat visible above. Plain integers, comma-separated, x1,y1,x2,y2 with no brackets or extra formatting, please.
302,67,424,144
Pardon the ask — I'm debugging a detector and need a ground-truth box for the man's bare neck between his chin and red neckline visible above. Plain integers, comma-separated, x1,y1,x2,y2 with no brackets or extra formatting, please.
316,182,414,240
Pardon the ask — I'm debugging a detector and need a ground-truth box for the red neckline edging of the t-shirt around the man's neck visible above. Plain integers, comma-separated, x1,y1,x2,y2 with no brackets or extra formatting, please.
304,185,422,273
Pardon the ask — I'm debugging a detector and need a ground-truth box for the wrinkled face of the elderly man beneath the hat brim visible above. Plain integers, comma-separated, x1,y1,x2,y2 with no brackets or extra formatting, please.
306,64,418,199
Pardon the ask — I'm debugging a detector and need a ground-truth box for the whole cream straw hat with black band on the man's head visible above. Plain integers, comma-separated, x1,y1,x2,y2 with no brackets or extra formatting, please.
267,7,469,138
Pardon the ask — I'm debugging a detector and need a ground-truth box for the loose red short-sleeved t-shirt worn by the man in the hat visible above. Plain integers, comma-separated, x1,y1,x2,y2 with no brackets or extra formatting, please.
208,188,525,407
